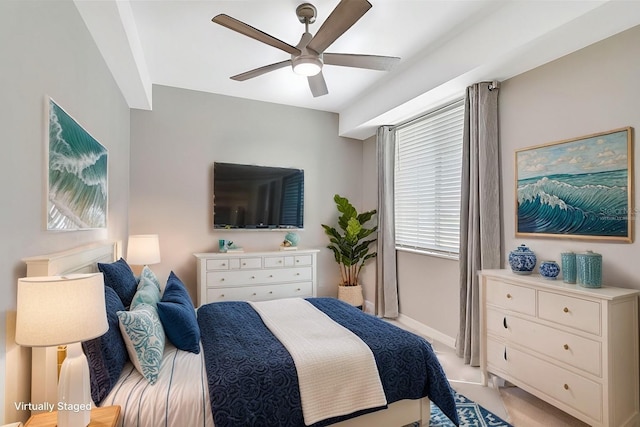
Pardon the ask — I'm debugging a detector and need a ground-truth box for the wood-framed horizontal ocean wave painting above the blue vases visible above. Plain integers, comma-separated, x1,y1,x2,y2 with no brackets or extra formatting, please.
515,127,634,243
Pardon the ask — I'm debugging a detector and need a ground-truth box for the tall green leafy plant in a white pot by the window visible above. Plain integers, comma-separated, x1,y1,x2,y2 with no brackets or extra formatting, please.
322,194,378,307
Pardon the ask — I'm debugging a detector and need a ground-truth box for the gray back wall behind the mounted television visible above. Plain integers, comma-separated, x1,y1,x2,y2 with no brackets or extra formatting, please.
129,86,363,301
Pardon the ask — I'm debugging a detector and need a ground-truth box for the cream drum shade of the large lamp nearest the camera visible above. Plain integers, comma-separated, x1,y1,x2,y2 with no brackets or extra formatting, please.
16,273,109,347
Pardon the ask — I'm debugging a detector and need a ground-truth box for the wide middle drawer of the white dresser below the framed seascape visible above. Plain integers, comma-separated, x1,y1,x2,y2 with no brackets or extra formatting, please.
487,309,602,376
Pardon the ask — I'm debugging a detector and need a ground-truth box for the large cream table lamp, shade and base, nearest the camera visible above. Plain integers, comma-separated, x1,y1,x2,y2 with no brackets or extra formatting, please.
16,273,109,427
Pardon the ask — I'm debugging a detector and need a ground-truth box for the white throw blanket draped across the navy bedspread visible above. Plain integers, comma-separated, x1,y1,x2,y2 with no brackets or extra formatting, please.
250,298,387,425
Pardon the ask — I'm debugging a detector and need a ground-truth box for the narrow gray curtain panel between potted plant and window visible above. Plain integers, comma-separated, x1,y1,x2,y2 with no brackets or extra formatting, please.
376,126,398,319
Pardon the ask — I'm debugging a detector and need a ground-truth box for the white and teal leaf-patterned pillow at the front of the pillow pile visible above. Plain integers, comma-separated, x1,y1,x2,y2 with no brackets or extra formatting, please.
117,303,165,384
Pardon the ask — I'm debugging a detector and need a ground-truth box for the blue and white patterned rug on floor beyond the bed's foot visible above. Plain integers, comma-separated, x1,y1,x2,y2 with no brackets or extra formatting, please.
429,391,513,427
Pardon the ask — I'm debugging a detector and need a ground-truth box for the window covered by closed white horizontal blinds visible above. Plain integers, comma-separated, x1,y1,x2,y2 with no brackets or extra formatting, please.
394,100,464,258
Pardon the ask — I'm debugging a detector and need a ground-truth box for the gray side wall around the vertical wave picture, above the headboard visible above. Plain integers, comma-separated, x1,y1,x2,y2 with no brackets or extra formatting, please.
0,0,129,424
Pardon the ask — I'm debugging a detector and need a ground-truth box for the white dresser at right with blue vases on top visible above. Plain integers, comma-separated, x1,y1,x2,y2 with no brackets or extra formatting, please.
479,270,640,427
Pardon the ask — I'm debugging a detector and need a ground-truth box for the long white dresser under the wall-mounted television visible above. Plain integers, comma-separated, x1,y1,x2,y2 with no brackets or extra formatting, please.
194,249,319,306
